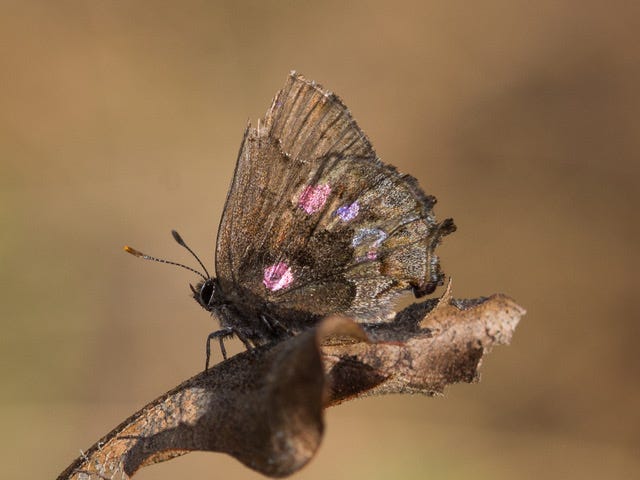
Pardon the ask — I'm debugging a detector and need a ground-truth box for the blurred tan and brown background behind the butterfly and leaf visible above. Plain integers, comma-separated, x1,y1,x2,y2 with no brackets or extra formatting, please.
0,0,640,479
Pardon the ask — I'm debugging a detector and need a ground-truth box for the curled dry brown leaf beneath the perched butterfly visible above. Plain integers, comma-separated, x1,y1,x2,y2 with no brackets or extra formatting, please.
58,289,525,480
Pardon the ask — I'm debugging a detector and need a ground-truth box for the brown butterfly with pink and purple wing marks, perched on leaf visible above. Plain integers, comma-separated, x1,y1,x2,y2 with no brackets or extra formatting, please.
125,72,456,367
